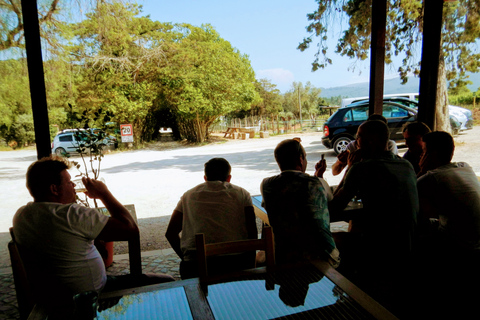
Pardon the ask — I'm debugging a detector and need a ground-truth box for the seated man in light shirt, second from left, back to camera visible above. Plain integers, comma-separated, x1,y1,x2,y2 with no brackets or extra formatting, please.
165,158,258,279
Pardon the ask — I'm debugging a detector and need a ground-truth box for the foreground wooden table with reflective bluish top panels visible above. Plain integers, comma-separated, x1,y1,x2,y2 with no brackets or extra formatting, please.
90,261,396,320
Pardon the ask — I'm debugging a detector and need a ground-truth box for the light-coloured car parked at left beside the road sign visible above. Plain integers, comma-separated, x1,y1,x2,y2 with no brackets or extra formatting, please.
52,129,118,156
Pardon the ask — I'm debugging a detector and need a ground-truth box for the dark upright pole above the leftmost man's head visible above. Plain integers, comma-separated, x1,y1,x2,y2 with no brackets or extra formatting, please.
22,0,51,159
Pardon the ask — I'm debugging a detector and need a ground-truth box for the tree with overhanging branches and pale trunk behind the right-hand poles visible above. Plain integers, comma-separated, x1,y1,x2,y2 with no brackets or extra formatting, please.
298,0,480,130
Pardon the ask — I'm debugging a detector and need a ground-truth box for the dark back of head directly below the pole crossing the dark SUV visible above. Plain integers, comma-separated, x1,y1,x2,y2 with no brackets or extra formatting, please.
356,120,390,154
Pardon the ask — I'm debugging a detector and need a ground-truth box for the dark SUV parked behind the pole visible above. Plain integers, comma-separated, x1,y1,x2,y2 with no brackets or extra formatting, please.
322,101,417,154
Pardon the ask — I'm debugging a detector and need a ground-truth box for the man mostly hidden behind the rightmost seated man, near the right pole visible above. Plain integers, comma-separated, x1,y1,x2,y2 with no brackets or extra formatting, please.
403,122,430,173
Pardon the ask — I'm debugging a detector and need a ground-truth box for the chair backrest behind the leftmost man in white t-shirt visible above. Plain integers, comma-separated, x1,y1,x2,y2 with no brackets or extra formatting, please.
8,228,35,319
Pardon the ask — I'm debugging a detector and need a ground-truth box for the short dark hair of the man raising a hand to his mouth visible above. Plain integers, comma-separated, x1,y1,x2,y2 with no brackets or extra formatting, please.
26,156,72,199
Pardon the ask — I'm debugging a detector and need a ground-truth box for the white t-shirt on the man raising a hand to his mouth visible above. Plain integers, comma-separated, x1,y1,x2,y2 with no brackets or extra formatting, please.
13,202,108,293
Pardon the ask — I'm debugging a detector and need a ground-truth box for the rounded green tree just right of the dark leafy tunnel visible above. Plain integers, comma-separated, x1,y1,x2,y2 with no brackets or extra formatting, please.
158,24,260,142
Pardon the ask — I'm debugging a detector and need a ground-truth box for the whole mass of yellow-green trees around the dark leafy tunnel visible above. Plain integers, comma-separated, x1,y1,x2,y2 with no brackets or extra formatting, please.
0,0,262,143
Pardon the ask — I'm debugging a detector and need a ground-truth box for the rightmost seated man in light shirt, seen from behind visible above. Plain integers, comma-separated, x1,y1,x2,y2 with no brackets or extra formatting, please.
417,131,480,255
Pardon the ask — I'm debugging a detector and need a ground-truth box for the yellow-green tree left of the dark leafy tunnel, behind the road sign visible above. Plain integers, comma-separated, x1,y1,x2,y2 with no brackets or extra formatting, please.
68,2,171,141
